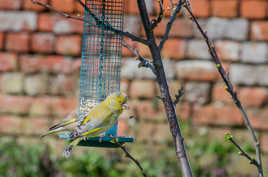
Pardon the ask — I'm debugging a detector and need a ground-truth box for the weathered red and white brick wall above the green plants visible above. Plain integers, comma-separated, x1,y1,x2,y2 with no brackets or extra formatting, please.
0,0,268,151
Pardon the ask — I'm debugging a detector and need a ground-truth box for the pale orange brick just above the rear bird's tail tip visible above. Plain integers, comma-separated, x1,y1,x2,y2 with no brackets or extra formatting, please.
21,117,49,135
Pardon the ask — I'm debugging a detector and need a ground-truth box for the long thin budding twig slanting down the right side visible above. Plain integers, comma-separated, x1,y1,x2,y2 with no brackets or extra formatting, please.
184,3,263,177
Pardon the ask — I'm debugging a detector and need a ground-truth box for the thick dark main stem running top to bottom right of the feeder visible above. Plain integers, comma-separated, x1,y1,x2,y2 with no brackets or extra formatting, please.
137,0,193,177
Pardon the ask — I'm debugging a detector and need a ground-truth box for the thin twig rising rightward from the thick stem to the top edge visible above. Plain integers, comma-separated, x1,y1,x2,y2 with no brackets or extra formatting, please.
159,0,184,51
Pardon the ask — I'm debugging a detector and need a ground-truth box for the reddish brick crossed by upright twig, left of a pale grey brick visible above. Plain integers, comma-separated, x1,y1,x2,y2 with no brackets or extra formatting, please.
154,18,194,37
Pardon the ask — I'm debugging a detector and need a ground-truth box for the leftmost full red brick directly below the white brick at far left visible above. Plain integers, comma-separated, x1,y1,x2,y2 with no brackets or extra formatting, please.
6,33,30,52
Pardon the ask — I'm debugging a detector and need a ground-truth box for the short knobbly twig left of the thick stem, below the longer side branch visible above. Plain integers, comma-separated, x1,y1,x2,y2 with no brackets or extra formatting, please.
122,40,156,74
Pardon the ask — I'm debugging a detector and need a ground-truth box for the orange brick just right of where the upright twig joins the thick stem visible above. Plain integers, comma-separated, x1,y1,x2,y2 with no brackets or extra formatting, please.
162,39,185,59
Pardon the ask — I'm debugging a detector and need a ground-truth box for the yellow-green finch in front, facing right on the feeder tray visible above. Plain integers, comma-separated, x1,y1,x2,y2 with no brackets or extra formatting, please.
63,92,128,157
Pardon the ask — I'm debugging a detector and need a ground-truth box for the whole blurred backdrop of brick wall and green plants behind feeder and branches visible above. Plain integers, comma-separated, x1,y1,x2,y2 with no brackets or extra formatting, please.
0,0,268,177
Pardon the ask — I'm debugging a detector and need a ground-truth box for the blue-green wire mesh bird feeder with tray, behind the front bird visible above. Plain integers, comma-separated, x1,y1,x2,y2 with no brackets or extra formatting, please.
62,0,134,147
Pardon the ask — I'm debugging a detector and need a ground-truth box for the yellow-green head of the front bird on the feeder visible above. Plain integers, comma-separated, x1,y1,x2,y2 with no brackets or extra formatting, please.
105,92,129,110
